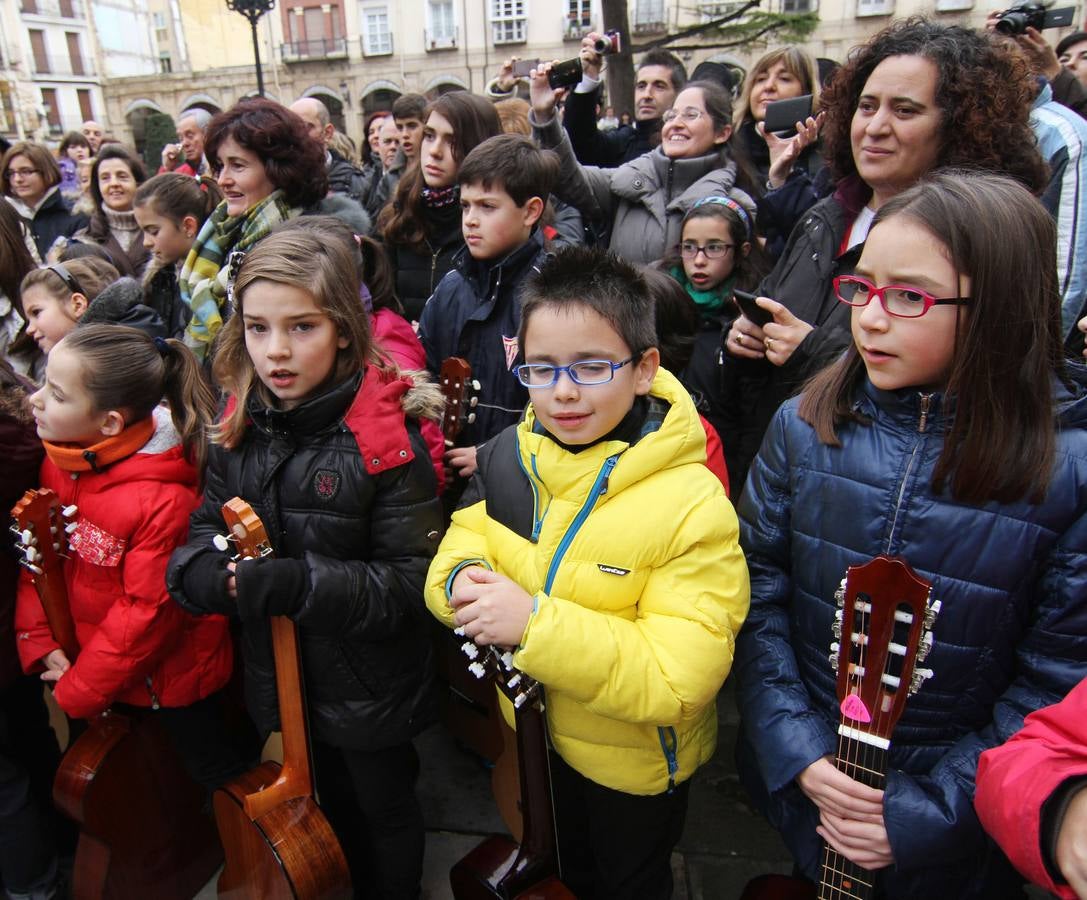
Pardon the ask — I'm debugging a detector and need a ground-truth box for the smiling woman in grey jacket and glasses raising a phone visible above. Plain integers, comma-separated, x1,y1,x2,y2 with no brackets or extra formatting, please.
530,63,754,263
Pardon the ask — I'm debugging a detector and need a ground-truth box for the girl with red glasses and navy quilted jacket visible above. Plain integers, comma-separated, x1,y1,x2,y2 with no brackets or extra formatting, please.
736,171,1087,898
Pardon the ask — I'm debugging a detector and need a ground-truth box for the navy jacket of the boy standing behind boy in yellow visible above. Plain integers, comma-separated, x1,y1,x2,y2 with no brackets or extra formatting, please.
418,228,548,447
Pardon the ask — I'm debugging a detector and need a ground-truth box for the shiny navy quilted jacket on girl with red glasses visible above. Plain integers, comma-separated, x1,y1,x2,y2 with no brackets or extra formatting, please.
734,370,1087,898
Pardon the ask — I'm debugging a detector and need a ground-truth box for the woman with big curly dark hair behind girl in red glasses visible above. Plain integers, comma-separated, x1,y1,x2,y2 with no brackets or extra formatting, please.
725,18,1049,487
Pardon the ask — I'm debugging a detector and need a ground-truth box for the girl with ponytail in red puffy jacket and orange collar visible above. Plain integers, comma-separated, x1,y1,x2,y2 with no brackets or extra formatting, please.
15,325,254,787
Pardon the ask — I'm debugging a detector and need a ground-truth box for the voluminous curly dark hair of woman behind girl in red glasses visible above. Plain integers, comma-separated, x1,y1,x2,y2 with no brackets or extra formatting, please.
823,16,1049,193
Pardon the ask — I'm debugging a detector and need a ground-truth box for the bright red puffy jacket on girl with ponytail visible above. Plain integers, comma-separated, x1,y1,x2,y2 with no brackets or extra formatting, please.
15,408,234,718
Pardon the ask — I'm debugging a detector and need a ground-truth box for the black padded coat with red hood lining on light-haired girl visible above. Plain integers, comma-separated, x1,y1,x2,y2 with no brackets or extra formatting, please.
166,366,442,750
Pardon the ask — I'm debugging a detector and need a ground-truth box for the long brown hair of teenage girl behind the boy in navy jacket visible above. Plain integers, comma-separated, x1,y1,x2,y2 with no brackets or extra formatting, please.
377,90,502,250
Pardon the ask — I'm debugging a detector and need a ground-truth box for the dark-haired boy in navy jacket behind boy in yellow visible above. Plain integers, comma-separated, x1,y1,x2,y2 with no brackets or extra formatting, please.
418,135,559,477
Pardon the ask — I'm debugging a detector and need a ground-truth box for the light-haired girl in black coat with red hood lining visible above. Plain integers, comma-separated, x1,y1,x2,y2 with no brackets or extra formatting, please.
167,229,441,898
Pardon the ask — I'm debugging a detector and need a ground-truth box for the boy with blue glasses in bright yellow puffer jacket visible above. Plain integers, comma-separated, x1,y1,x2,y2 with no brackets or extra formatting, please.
426,248,749,900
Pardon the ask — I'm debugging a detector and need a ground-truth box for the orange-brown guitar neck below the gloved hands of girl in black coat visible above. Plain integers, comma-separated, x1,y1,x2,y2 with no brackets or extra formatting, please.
246,615,313,818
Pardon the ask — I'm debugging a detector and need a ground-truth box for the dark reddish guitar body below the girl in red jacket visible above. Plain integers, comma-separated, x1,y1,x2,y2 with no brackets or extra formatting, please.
53,712,223,900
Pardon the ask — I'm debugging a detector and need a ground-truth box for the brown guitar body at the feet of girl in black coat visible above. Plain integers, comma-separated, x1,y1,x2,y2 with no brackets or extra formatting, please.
215,762,351,900
